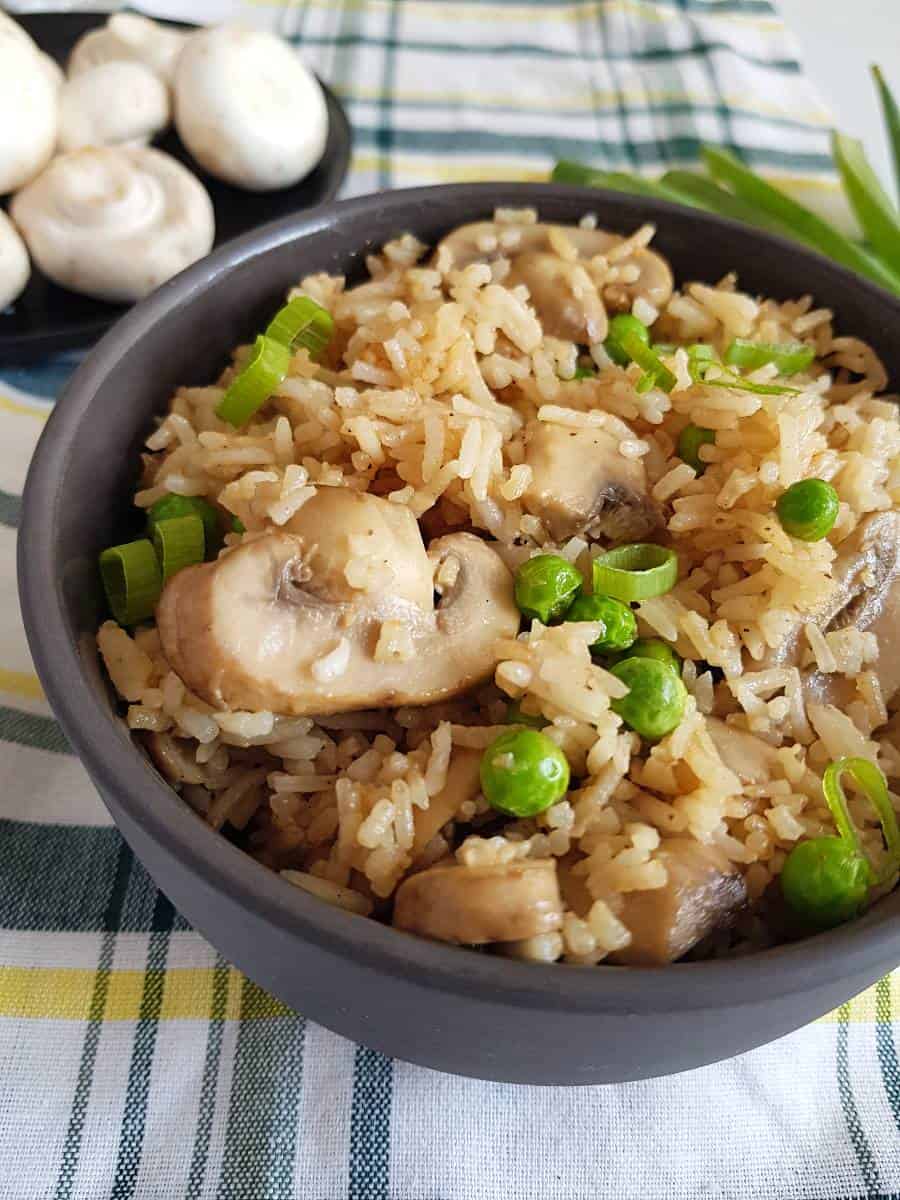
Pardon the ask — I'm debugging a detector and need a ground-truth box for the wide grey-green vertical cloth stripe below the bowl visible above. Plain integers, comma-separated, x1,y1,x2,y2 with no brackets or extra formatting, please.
216,979,306,1200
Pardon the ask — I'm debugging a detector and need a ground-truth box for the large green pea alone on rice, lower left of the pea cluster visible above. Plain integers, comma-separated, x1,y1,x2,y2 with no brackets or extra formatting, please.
481,730,569,817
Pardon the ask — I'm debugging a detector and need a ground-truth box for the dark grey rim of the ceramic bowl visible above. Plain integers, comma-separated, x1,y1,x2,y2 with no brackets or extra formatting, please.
17,182,900,1015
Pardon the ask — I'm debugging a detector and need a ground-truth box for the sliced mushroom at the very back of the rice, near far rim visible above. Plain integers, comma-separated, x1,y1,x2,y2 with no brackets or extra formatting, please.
434,221,673,328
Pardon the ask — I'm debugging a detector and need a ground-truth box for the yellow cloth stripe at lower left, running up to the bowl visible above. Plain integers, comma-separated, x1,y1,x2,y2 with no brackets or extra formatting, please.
0,967,293,1021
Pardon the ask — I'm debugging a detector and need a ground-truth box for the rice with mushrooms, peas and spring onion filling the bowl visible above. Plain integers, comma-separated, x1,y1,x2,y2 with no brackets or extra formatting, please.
97,210,900,965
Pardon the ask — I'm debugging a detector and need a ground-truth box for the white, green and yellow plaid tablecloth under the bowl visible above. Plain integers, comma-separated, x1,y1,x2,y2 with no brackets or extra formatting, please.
0,0,900,1200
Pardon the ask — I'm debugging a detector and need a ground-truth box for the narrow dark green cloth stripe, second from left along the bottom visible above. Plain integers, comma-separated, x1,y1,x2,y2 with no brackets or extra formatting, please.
110,892,175,1200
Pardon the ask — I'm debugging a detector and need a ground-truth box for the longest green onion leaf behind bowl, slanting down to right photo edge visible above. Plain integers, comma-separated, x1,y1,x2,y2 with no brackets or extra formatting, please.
703,146,900,295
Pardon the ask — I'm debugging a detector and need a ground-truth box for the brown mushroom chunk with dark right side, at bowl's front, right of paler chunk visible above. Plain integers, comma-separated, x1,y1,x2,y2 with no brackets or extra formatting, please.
610,838,746,966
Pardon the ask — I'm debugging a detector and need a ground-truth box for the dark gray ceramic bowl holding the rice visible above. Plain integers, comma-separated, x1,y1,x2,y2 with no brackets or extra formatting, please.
19,184,900,1084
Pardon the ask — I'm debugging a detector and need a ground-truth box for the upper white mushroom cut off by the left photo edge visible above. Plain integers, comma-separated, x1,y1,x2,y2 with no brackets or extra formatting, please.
0,36,58,193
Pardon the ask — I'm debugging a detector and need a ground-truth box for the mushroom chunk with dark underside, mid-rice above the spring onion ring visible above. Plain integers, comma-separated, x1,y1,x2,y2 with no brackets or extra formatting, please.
522,421,662,541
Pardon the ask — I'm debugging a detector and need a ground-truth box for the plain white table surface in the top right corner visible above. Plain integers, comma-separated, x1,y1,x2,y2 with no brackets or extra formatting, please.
776,0,900,192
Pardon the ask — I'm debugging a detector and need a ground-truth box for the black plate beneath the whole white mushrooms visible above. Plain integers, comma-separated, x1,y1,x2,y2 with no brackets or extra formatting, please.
0,12,350,364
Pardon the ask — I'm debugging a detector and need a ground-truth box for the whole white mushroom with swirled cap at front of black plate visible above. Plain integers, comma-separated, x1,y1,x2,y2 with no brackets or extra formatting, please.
12,146,214,301
